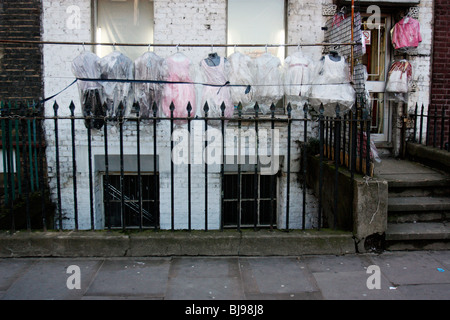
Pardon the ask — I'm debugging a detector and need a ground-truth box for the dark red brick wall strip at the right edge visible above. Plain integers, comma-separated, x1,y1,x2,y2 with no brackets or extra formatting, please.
428,0,450,146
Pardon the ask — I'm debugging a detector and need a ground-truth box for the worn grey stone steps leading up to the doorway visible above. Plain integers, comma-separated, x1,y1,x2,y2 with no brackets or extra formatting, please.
378,160,450,250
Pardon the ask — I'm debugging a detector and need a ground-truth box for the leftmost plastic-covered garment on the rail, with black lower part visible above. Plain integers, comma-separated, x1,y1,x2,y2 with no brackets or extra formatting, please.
72,51,105,129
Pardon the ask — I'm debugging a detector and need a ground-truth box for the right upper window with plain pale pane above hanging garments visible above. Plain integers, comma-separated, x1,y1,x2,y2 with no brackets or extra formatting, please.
228,0,286,61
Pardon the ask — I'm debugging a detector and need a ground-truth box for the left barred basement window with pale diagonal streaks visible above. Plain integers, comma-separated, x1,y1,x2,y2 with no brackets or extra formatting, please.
103,174,159,228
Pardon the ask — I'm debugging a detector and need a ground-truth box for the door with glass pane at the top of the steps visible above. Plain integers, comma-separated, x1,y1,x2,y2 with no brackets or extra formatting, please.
362,16,391,142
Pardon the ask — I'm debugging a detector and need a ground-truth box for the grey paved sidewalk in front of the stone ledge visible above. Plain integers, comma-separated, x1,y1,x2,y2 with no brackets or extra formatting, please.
0,251,450,300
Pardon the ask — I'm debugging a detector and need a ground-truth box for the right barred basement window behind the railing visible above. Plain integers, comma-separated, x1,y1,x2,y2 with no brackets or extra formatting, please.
223,173,277,227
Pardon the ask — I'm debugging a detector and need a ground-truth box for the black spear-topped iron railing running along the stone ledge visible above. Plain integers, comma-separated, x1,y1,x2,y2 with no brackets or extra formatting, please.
0,102,373,231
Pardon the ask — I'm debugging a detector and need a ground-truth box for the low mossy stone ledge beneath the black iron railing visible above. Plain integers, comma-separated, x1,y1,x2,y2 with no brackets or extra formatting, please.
0,230,355,258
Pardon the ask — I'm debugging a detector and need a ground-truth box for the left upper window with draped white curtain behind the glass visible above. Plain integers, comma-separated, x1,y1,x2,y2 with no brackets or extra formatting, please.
94,0,154,60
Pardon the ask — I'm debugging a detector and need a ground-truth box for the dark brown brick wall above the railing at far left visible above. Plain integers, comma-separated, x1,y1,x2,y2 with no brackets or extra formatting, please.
0,0,43,101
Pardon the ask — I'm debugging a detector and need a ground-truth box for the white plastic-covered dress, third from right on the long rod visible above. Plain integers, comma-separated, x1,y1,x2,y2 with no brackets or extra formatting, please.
254,53,284,114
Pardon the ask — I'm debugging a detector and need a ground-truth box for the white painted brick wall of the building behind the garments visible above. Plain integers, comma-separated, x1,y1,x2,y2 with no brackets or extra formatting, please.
42,0,432,229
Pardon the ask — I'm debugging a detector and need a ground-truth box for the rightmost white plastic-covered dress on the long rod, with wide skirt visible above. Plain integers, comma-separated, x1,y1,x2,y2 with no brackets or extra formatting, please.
308,55,356,117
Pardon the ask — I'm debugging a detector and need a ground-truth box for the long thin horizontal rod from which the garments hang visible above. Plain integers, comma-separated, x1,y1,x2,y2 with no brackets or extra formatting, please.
0,39,361,48
